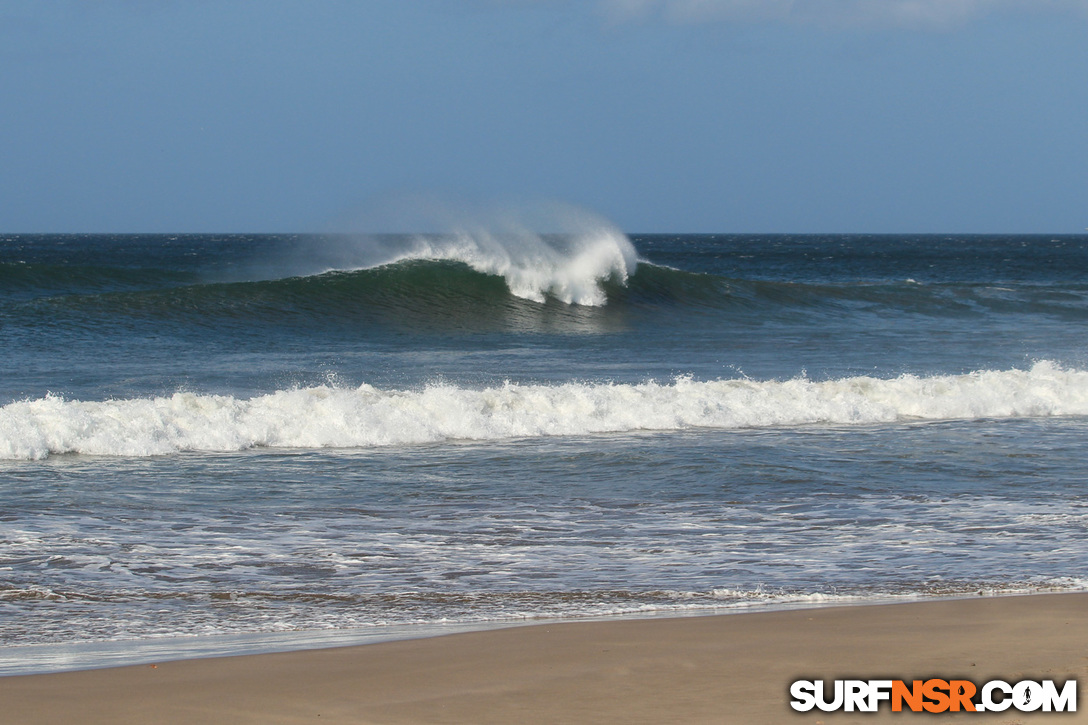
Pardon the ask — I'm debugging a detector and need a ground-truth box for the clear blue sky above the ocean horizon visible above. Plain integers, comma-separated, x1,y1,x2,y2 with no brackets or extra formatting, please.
0,0,1088,234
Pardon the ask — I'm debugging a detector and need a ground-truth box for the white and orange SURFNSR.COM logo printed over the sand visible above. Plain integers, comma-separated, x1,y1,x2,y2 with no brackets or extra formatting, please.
790,678,1077,712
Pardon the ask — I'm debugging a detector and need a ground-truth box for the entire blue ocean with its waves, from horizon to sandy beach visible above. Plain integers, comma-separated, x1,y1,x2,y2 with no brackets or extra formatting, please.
0,224,1088,674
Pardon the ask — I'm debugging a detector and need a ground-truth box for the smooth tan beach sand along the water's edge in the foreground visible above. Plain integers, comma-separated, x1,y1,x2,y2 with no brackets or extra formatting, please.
0,593,1088,725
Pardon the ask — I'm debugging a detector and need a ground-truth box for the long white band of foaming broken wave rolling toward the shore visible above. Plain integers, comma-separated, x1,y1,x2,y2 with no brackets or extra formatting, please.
0,361,1088,459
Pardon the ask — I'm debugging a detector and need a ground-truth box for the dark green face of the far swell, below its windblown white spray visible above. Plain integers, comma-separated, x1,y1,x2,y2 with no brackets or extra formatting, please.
8,259,1088,325
